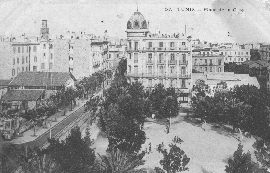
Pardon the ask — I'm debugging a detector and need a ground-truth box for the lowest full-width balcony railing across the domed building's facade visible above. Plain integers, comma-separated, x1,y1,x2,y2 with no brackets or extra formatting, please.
126,73,191,79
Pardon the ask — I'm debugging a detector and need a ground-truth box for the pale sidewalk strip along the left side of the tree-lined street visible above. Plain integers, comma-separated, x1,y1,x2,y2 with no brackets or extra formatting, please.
11,100,87,144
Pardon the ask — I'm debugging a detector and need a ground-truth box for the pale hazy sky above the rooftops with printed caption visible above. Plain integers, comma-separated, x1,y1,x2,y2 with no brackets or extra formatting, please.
0,0,270,43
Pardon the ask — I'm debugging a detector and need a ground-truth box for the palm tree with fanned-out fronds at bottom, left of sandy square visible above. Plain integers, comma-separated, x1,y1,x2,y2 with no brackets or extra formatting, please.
98,149,145,173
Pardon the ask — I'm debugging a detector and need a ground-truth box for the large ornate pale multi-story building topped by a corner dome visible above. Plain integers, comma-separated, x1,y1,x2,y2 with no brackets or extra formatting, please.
126,11,192,102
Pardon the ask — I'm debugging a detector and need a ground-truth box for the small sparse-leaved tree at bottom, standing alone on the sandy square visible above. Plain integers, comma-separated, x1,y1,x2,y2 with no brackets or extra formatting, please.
160,144,190,173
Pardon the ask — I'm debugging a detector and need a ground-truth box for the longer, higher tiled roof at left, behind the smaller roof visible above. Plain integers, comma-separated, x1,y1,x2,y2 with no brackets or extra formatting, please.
9,72,75,86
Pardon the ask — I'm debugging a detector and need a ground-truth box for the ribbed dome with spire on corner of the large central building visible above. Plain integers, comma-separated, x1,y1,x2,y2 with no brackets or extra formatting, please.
127,11,148,29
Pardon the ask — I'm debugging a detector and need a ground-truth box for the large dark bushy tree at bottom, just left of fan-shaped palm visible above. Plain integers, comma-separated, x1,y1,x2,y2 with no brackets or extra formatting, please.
47,127,95,173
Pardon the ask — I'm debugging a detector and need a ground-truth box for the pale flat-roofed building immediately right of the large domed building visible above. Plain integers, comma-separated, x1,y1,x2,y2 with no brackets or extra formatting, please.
192,49,224,73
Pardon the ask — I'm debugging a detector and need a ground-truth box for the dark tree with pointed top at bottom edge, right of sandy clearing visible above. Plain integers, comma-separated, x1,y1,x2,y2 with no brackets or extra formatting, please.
225,144,260,173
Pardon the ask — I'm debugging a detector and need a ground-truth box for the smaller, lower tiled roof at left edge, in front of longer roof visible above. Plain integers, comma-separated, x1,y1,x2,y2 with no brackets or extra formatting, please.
1,89,44,101
